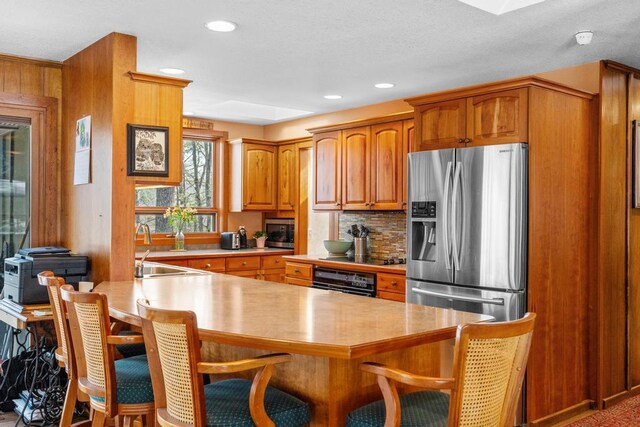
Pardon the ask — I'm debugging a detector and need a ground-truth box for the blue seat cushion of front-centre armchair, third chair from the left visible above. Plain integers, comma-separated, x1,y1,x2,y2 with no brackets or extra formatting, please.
204,379,311,427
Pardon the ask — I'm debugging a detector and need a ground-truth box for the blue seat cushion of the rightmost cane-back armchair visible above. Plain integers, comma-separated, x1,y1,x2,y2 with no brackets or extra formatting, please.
347,391,449,427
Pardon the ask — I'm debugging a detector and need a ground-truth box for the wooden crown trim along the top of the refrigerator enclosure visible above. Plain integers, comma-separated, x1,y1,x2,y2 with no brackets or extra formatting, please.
405,76,594,107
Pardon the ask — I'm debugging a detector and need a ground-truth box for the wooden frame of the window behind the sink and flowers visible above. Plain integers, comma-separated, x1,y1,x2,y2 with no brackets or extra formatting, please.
135,128,227,246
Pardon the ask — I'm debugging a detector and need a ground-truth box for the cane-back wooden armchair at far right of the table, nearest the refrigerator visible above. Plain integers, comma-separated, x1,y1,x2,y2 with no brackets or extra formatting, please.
347,313,536,427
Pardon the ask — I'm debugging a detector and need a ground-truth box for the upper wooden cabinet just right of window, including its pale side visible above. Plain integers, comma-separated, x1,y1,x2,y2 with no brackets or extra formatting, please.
229,138,278,212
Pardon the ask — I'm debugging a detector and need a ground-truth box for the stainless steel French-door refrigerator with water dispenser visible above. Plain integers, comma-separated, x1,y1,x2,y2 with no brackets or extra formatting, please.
407,144,528,321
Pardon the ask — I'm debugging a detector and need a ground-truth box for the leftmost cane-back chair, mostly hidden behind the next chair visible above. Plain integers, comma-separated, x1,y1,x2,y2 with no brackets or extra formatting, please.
38,271,89,426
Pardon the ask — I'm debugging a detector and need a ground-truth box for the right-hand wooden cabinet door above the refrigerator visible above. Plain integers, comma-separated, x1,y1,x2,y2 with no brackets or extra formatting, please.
467,89,528,145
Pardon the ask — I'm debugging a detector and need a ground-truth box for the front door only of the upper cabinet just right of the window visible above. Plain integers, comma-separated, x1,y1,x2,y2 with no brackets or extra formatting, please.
242,143,277,211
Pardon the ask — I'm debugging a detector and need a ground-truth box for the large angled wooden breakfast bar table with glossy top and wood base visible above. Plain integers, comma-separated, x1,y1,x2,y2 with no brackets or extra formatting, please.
95,274,491,426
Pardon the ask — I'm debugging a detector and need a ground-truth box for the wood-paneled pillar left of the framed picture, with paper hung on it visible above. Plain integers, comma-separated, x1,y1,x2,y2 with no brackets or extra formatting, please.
62,33,136,283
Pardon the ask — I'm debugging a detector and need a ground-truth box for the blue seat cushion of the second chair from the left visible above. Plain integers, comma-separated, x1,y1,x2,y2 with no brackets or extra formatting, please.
91,355,154,404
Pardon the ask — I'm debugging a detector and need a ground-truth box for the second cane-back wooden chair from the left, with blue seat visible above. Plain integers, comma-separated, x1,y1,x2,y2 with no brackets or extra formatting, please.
60,285,155,426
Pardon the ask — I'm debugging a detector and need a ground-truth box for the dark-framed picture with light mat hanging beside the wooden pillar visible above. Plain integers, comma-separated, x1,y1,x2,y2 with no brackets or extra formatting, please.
127,124,169,176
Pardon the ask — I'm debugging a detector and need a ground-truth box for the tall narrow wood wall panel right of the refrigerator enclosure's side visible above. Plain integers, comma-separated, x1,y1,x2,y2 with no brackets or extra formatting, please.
597,64,628,403
